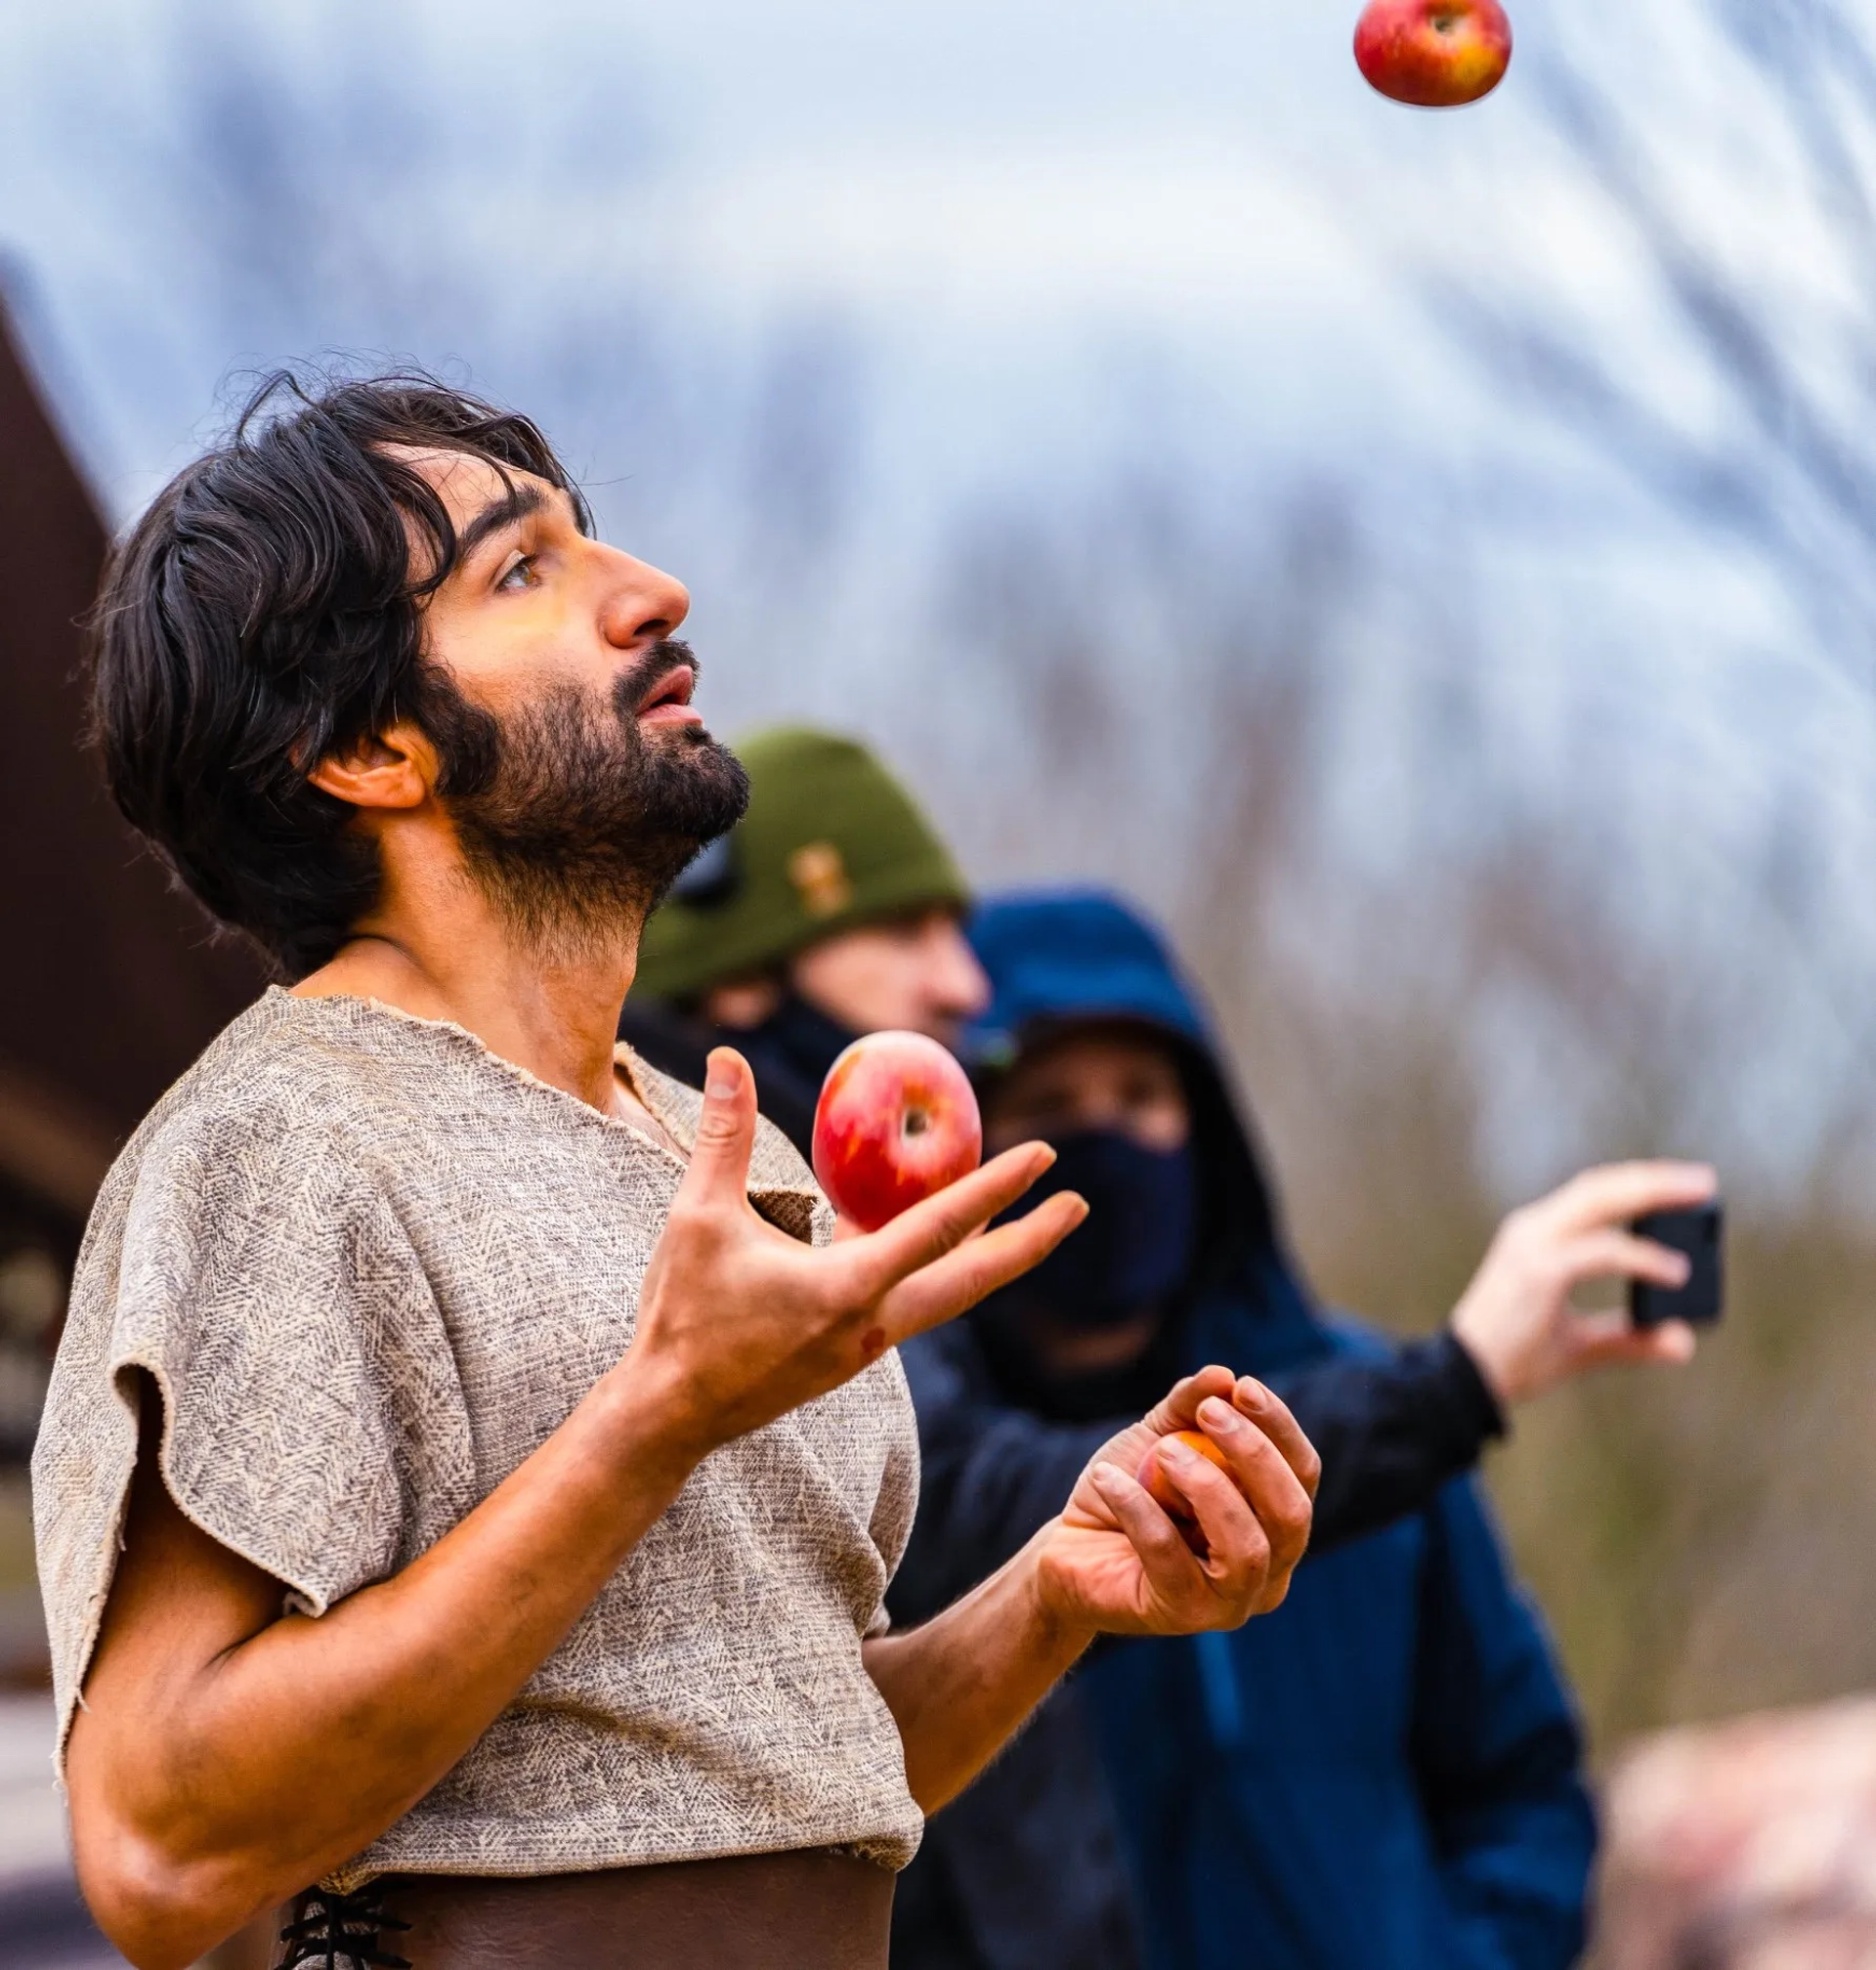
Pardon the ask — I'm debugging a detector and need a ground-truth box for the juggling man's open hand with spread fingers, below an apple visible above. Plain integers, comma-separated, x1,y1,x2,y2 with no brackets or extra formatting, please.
620,1046,1087,1458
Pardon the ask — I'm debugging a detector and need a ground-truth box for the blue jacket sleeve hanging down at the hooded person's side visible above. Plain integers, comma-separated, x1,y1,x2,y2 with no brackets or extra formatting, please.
1413,1481,1597,1970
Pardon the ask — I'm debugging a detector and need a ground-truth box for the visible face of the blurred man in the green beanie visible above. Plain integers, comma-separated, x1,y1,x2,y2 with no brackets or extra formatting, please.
789,910,989,1046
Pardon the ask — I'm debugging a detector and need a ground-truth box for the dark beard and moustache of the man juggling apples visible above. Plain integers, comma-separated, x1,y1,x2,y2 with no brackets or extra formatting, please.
420,642,748,954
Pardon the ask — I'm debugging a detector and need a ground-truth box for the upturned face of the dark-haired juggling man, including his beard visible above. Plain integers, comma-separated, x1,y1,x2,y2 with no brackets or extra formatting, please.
396,453,746,936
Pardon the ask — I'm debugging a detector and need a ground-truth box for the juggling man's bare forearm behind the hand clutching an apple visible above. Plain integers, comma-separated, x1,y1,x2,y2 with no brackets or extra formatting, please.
865,1526,1093,1813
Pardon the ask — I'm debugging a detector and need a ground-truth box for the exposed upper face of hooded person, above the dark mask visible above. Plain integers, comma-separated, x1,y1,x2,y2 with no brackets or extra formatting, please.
983,1024,1192,1154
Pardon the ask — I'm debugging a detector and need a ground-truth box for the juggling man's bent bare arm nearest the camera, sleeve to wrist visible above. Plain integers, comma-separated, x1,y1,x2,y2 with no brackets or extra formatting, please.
69,1357,696,1970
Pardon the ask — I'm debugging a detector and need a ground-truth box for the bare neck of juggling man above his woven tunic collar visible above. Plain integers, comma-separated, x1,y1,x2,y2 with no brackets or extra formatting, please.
294,850,662,1133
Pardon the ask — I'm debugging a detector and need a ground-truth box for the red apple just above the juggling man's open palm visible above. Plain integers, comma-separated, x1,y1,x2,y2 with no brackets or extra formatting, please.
814,1032,983,1231
